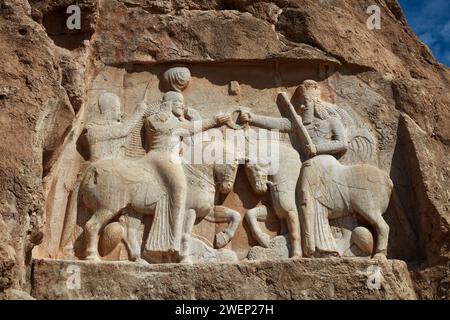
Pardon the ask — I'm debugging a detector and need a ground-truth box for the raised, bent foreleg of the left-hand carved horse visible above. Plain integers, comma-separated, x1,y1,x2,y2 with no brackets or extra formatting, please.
213,206,241,249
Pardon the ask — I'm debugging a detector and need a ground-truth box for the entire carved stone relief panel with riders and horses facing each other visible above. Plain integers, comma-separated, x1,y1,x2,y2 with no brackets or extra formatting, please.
35,65,413,263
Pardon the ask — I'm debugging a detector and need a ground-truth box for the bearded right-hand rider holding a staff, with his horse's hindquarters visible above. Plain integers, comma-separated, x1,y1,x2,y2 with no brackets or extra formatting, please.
240,80,400,257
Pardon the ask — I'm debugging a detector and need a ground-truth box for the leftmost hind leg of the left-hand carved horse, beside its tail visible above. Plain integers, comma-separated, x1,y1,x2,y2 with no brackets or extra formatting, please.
85,209,118,261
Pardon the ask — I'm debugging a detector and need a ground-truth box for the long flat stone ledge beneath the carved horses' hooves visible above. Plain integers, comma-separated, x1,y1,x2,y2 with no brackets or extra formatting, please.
32,258,416,299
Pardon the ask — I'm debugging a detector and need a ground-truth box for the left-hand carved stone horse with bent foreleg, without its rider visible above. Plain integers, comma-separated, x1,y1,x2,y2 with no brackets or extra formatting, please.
62,141,241,262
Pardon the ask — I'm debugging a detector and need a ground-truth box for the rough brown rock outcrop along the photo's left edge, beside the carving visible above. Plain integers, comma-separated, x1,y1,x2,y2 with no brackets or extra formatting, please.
0,1,74,290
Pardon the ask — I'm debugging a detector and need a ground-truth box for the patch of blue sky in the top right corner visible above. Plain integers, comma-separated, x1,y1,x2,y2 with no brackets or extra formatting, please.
399,0,450,66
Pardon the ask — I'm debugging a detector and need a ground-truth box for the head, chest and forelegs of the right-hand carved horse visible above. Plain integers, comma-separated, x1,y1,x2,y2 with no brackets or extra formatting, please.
245,142,302,258
